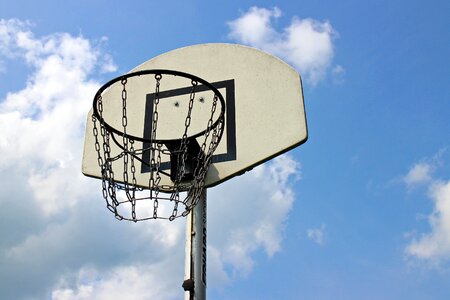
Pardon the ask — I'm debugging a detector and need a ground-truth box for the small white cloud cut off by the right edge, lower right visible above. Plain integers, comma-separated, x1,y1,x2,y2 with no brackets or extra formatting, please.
406,181,450,262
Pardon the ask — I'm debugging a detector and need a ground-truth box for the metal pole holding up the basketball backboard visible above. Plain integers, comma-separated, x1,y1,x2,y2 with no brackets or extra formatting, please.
183,189,206,300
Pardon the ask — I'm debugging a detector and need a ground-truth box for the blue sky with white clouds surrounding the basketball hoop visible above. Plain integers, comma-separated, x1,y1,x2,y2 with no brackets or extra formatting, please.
0,0,450,300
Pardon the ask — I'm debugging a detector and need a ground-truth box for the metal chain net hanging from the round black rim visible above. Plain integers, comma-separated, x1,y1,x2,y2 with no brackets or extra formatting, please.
92,70,225,222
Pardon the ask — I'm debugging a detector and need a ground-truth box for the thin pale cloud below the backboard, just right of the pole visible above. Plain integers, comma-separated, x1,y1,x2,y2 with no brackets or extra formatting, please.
208,155,300,281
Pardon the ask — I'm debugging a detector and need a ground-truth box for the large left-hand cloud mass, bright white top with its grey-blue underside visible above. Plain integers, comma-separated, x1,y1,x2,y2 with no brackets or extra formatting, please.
0,20,160,299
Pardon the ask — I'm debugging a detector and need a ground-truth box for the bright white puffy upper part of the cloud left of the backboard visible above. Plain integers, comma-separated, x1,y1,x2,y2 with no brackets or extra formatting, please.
0,20,114,215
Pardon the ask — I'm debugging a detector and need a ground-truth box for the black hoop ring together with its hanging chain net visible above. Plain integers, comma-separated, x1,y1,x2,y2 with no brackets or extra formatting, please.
92,69,225,222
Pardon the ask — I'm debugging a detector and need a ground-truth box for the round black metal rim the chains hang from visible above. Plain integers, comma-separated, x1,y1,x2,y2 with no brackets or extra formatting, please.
92,69,225,144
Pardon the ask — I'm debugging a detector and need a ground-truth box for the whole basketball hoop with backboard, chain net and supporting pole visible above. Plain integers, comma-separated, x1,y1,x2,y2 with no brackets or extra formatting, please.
82,44,308,300
